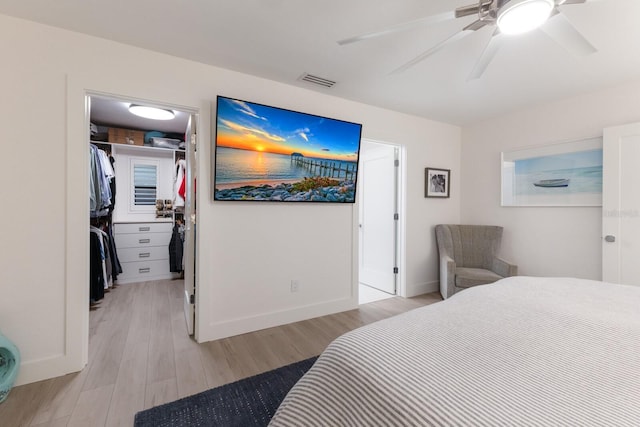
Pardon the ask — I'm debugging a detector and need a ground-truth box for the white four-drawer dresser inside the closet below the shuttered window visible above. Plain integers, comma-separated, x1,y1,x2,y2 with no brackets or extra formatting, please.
113,222,174,283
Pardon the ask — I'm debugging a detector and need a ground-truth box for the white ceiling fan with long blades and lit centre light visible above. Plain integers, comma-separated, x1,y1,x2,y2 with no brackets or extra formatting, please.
338,0,598,80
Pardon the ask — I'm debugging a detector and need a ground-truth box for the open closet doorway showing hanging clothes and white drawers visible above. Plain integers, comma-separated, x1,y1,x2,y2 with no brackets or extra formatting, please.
86,94,197,342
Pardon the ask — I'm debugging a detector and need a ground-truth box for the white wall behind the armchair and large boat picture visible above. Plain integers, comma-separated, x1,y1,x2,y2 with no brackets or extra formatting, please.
461,82,640,280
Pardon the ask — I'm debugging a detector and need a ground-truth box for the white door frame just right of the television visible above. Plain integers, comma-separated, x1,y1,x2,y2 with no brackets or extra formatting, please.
354,138,407,297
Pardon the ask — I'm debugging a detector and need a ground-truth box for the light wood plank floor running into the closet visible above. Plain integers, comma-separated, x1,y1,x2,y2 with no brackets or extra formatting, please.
0,280,440,427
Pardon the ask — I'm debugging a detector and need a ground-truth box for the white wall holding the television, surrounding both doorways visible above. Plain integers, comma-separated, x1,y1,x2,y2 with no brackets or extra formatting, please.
0,16,460,383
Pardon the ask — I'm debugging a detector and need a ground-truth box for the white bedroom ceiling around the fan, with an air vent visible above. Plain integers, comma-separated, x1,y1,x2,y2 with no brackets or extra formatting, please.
0,0,640,125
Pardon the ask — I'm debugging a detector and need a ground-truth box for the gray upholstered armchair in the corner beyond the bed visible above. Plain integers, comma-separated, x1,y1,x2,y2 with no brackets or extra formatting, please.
436,224,518,299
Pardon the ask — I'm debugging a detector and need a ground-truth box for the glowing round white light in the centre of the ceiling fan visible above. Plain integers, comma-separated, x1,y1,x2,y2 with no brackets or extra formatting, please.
497,0,555,34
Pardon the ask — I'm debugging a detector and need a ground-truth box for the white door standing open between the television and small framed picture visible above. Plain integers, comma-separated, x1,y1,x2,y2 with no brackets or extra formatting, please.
359,141,398,294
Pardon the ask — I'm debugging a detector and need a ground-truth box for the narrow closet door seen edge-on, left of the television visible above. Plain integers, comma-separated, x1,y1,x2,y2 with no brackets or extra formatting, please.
184,114,197,335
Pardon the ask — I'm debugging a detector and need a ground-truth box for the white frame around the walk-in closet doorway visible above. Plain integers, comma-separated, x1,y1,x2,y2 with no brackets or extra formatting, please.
65,76,202,377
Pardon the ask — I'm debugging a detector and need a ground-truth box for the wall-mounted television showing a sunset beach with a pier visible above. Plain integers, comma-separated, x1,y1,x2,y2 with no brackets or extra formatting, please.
214,96,362,203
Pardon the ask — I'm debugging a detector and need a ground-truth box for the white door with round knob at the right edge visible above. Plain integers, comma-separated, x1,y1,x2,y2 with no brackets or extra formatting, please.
602,123,640,285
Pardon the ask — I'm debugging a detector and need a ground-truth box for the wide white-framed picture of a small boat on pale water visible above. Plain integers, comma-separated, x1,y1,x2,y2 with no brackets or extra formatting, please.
502,137,602,206
